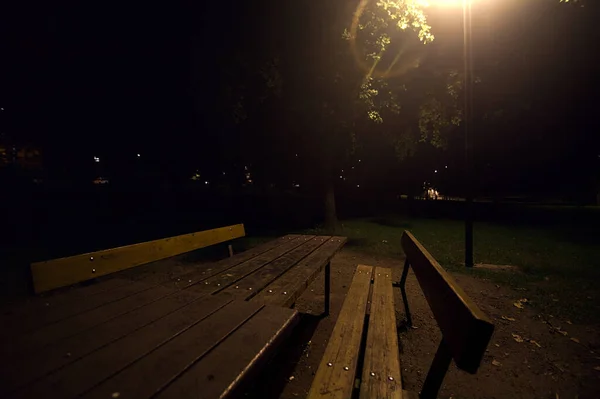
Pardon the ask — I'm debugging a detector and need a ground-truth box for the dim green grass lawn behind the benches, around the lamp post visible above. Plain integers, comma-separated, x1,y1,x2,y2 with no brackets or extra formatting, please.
309,217,600,324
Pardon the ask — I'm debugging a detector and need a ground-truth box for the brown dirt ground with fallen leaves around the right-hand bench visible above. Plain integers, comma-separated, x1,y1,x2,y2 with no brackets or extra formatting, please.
247,249,600,399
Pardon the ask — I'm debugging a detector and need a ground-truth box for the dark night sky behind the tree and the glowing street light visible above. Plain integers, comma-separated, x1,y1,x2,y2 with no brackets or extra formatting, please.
0,0,600,199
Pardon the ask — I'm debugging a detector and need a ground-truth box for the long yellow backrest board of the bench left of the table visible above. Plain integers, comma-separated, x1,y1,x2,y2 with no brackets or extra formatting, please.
31,224,245,293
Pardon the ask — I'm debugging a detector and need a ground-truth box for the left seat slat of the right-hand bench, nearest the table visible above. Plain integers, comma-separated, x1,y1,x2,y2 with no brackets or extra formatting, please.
308,265,373,399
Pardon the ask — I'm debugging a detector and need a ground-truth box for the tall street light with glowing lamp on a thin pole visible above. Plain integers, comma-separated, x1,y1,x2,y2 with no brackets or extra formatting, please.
431,0,474,267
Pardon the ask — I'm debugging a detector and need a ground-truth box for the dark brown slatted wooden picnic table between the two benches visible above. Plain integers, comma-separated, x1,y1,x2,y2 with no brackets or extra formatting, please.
0,235,346,398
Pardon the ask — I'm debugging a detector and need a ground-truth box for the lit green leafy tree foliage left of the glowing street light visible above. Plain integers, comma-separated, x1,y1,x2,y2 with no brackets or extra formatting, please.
342,0,462,158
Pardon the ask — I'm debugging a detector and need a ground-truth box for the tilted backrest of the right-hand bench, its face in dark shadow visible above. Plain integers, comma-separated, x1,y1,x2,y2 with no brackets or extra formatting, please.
402,231,494,373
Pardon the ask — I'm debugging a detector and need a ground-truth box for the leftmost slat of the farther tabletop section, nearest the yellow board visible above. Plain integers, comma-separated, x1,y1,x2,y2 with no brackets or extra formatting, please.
162,234,299,288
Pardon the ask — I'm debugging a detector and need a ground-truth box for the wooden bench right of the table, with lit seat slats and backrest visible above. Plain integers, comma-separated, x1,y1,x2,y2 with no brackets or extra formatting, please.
308,232,494,399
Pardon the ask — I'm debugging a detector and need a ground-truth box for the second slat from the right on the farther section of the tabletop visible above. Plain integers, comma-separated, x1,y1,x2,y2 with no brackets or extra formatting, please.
218,237,329,300
